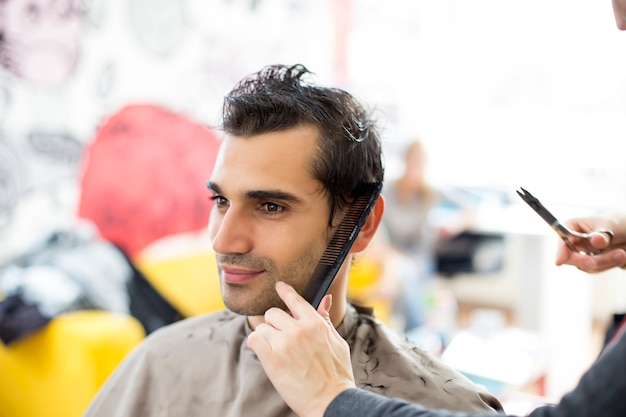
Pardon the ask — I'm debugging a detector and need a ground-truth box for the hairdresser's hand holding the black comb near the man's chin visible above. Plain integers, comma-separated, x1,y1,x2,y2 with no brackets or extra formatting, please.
248,282,355,417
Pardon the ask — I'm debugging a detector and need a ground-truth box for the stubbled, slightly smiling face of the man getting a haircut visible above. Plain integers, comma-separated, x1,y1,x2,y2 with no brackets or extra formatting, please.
209,126,331,316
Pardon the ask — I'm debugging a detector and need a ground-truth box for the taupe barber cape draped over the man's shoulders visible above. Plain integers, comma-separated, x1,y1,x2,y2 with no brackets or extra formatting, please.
84,306,502,417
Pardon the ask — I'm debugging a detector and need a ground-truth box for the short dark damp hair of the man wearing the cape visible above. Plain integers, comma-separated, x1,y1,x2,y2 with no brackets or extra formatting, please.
222,64,384,224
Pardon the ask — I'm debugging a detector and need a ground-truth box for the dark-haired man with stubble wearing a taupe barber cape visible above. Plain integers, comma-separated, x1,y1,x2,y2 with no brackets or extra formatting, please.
81,65,502,417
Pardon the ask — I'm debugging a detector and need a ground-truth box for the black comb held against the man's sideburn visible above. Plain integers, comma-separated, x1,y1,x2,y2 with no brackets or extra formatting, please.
302,182,383,308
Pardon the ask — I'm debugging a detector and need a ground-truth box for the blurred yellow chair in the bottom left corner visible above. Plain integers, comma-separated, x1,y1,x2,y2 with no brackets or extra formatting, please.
0,310,145,417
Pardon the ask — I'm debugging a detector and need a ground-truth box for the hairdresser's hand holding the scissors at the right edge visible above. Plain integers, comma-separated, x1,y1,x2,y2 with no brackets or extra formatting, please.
556,214,626,273
